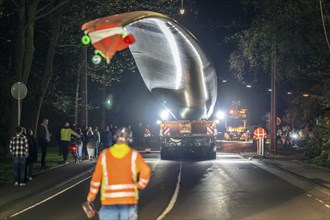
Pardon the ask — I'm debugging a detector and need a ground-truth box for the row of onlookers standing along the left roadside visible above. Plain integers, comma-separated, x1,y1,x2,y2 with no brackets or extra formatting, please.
9,119,152,186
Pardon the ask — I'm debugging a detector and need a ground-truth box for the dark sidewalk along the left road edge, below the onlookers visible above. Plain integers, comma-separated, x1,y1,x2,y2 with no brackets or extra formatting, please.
0,160,95,219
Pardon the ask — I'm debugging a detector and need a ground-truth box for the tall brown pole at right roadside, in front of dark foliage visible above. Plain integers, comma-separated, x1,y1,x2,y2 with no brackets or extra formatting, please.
270,33,277,155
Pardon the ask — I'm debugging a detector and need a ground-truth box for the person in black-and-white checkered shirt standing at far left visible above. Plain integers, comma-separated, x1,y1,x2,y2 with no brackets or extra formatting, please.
9,127,29,186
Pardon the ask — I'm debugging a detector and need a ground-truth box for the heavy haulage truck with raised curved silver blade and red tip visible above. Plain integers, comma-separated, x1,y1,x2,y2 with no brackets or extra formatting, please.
82,11,217,158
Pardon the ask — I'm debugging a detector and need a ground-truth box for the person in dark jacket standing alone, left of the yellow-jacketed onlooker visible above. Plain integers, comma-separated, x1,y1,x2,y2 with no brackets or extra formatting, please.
38,118,50,168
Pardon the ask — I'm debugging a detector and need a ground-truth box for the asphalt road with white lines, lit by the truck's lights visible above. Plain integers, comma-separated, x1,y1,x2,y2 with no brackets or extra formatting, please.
10,142,330,220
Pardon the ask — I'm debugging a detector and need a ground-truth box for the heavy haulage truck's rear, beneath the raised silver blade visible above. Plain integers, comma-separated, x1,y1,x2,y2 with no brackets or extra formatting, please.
160,120,217,159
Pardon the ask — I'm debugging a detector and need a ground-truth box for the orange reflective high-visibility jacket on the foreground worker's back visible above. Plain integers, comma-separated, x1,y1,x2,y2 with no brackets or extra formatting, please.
87,148,150,205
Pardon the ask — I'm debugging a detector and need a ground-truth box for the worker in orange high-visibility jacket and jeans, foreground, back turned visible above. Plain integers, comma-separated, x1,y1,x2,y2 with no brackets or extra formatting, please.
87,128,150,220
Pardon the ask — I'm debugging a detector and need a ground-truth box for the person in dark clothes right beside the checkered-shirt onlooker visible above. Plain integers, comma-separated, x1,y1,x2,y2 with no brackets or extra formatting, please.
25,129,38,180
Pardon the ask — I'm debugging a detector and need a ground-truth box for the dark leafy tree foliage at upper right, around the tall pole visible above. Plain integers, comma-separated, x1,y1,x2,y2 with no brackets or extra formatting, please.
229,0,330,84
